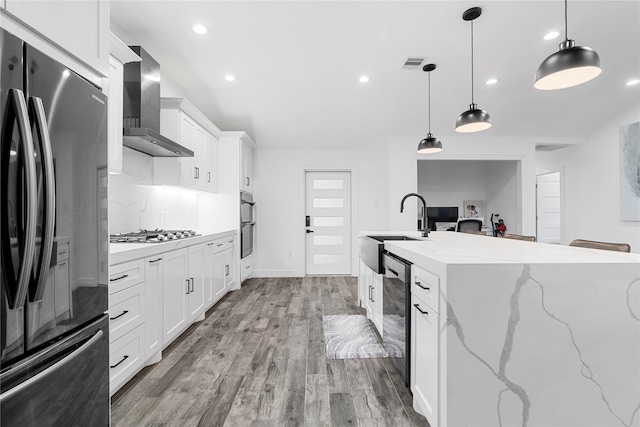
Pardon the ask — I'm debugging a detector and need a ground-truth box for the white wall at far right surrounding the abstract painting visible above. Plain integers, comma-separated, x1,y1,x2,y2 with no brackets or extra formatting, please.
536,104,640,253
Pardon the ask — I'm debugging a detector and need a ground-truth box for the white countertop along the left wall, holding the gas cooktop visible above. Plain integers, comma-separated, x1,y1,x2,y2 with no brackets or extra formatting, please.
109,230,237,265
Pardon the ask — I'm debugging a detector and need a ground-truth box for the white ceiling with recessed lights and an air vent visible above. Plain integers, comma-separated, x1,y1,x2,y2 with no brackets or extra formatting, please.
111,0,640,149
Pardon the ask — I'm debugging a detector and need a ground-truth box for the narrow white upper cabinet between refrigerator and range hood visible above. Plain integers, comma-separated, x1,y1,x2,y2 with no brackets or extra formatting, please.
102,33,141,174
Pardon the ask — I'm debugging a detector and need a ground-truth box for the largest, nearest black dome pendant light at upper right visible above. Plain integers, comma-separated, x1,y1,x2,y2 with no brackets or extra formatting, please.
533,0,602,90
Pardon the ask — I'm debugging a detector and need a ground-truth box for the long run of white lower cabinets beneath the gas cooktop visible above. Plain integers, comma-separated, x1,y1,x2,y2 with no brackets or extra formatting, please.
109,233,237,395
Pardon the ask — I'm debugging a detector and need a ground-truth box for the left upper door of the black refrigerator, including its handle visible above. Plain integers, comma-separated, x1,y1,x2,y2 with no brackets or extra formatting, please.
0,29,36,366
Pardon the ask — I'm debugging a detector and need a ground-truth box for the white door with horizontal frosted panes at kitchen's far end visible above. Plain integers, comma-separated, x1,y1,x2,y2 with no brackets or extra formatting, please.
305,171,351,275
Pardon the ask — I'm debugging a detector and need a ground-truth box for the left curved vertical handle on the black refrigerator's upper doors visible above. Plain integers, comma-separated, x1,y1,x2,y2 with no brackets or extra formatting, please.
2,88,37,309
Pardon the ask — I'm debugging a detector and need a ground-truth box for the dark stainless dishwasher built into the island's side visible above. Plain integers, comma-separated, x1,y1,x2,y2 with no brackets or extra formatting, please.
382,251,411,387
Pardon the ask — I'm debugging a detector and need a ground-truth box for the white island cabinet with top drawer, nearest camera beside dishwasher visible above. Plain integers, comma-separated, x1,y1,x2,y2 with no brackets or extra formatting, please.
411,267,440,426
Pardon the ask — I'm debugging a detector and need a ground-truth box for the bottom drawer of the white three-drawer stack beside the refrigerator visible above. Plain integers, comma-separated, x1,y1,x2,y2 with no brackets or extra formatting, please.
109,324,144,395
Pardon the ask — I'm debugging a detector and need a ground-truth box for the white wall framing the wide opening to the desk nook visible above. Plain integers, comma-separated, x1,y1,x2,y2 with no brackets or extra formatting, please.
388,135,540,235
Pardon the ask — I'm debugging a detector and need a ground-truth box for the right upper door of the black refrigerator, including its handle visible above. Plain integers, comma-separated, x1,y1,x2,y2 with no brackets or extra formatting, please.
25,45,108,351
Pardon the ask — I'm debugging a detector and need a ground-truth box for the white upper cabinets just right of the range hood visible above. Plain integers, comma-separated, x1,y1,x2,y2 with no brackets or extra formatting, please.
153,98,220,193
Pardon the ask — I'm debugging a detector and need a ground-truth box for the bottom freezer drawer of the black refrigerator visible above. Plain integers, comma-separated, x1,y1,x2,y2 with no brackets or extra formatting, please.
0,316,109,427
